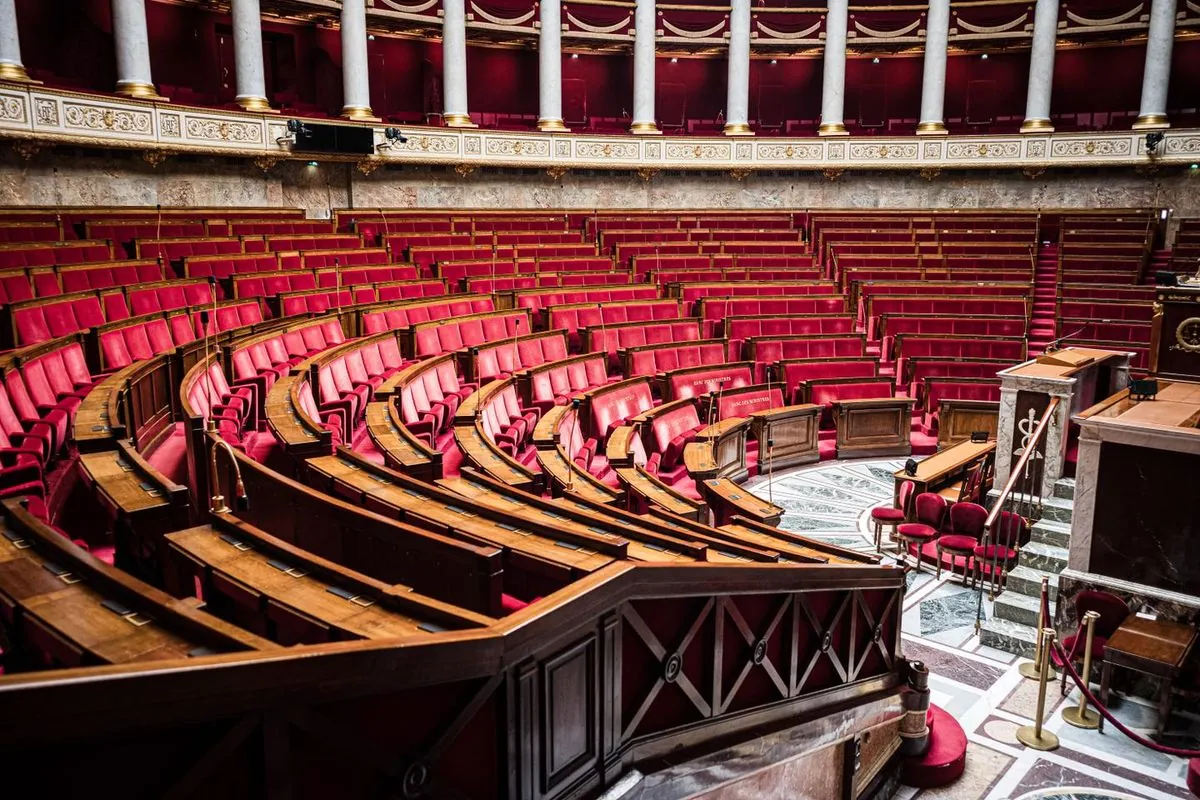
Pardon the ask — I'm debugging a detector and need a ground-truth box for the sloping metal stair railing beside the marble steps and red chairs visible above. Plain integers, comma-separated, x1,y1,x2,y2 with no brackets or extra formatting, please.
976,397,1061,633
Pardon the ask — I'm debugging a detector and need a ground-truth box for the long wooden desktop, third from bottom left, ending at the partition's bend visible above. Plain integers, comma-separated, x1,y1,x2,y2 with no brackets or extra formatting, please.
308,456,617,572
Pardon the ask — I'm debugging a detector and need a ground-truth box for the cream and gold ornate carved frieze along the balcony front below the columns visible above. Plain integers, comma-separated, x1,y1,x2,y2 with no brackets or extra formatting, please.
0,85,1200,176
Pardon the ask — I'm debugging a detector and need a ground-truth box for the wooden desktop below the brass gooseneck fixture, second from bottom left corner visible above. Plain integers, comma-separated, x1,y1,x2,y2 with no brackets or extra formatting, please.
167,528,427,639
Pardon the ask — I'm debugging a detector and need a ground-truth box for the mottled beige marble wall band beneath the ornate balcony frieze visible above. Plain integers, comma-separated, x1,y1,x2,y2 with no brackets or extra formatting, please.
7,149,1200,216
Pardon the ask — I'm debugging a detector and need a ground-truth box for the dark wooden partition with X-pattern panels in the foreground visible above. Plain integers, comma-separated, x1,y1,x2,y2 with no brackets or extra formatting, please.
0,563,904,800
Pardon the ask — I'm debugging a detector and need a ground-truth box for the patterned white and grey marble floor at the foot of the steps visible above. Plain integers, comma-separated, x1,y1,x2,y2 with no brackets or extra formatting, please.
746,459,1200,800
